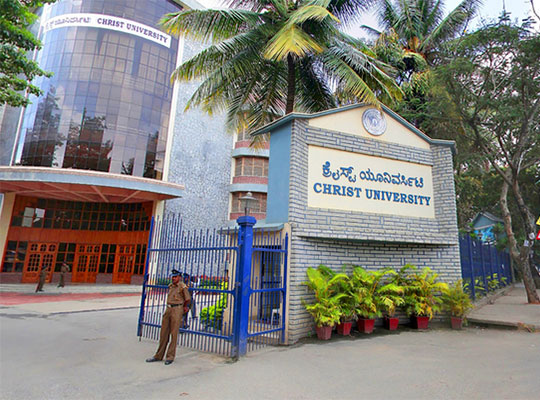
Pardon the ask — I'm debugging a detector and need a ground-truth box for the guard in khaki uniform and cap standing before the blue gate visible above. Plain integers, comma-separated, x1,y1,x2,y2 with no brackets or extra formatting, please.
146,269,191,365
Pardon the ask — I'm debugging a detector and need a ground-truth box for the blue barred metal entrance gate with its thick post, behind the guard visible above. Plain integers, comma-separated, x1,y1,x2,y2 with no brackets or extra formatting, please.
137,216,288,357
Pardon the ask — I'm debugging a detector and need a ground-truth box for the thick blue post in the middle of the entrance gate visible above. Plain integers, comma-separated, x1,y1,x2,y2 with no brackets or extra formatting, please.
233,215,257,357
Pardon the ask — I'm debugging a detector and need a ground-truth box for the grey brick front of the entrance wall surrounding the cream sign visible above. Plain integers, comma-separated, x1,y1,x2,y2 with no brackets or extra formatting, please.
288,120,461,343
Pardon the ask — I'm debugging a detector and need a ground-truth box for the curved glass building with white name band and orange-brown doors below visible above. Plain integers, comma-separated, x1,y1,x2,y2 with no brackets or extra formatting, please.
0,0,206,283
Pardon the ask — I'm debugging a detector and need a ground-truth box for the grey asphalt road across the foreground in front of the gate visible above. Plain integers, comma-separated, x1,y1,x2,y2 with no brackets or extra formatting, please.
0,307,540,400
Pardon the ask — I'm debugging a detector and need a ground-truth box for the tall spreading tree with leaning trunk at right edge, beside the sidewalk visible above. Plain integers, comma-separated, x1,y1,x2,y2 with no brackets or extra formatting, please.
437,17,540,304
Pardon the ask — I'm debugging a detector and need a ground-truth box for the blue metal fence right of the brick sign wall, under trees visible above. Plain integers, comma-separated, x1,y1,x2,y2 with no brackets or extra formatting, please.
459,235,512,300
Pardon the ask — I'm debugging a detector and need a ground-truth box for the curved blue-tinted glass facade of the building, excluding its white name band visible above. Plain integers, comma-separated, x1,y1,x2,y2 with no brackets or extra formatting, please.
16,0,180,179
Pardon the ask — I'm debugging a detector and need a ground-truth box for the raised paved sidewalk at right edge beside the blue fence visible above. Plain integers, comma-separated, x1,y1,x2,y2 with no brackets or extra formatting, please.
467,284,540,332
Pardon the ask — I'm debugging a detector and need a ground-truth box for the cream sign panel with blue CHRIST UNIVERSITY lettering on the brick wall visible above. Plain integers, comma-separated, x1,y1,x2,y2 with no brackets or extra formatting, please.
308,146,435,218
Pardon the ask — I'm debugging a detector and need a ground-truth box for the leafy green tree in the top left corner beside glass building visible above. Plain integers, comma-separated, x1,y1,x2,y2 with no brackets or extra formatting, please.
0,0,56,107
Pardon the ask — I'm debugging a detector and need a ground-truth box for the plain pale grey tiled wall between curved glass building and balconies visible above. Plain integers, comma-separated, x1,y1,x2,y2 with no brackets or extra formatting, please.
165,41,234,230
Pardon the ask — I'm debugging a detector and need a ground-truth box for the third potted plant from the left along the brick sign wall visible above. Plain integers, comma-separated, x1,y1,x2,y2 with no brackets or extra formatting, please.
351,266,388,333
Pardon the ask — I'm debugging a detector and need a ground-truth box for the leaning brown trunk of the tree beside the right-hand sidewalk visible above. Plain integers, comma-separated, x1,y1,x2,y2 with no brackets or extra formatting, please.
500,180,540,304
